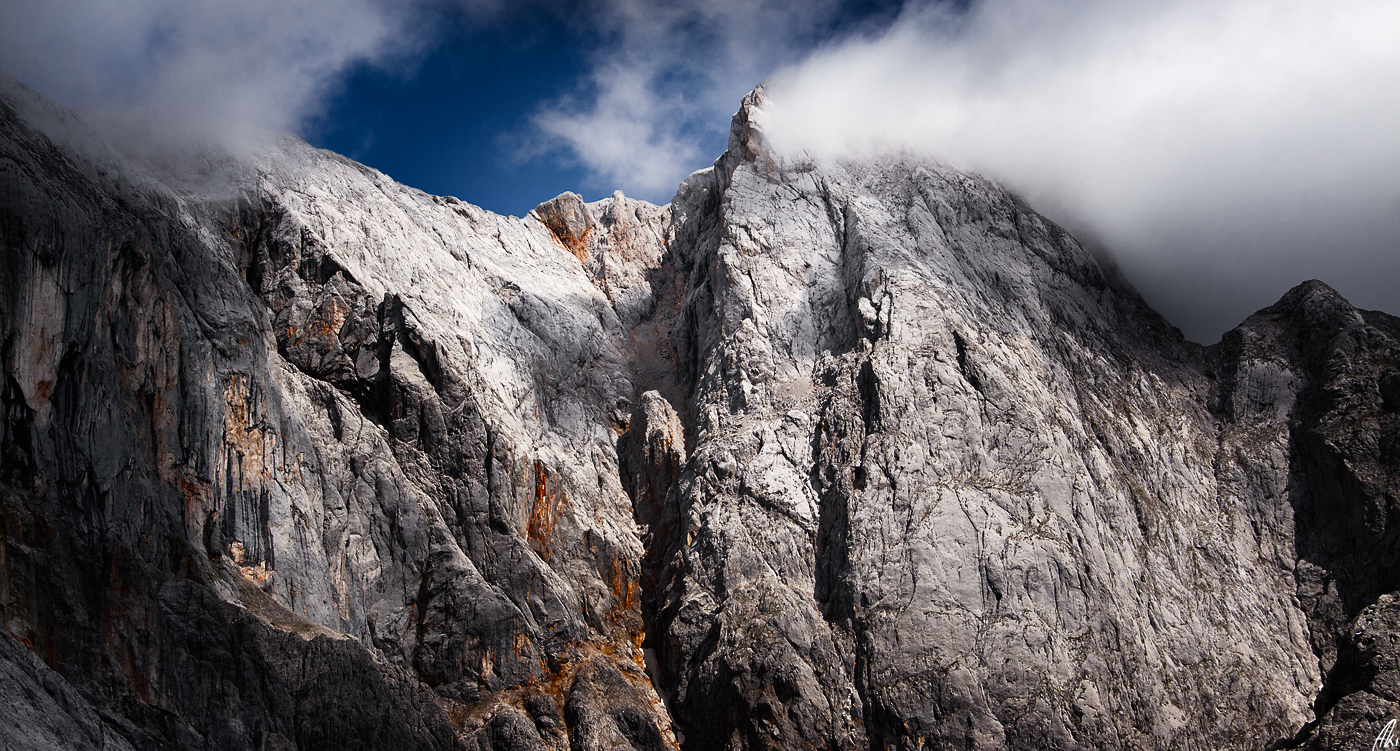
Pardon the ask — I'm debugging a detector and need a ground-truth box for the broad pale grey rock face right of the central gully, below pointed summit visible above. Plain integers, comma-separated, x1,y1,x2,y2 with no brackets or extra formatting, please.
641,92,1396,748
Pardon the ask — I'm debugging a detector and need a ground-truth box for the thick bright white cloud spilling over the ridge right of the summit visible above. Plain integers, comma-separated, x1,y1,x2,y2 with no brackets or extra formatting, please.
769,0,1400,339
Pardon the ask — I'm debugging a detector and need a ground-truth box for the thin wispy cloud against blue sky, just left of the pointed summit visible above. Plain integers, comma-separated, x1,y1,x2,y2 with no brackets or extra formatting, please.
535,0,840,200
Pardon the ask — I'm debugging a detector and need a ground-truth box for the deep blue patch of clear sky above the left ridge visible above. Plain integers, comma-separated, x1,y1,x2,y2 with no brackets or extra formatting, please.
300,15,596,216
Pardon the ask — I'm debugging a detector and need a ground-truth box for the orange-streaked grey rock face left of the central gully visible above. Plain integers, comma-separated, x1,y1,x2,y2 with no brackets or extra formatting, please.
0,74,673,748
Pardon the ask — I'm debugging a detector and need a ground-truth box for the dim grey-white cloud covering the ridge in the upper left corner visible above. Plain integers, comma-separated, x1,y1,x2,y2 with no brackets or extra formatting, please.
0,0,416,162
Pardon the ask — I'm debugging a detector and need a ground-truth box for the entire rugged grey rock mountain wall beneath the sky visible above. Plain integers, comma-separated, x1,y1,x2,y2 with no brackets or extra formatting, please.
0,81,1400,751
